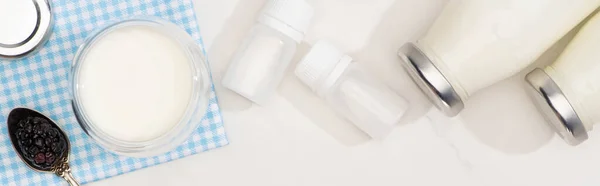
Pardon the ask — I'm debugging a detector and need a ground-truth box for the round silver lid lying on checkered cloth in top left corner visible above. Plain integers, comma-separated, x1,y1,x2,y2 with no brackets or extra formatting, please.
0,0,53,58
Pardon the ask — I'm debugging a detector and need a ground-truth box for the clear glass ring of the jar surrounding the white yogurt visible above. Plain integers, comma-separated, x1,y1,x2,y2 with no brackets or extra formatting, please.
70,17,211,157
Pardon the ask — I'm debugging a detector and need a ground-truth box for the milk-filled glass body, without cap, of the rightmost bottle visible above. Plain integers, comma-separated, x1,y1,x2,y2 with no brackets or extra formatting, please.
544,12,600,134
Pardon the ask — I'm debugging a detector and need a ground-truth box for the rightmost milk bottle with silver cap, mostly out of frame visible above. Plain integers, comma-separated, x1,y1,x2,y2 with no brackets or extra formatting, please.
527,12,600,145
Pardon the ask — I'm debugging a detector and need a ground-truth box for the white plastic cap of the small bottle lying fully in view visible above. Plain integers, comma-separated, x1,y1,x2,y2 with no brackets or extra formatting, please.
295,41,352,96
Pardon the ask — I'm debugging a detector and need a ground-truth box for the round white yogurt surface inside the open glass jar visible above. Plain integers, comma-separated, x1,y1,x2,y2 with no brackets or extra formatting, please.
78,25,193,142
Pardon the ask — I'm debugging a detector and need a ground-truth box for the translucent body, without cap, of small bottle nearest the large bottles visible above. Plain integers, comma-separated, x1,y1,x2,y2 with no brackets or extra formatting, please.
324,67,408,139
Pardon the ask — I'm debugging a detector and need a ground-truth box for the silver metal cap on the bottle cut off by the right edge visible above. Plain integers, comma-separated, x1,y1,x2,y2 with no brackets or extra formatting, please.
525,69,588,145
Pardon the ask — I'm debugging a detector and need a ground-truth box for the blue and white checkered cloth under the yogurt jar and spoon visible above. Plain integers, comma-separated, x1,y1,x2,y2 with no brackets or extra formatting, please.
0,0,228,185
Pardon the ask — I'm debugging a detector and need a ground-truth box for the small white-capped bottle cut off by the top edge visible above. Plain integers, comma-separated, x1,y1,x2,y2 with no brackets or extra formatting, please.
222,0,314,105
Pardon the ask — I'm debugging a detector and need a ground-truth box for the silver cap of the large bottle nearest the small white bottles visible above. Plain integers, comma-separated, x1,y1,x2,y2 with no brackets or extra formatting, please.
398,43,464,116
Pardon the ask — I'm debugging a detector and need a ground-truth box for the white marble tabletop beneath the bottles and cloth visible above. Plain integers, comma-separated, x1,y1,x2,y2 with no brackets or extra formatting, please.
89,0,600,186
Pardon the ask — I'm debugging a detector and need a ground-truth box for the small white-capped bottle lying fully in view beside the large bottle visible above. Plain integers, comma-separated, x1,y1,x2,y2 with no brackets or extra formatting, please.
295,41,407,139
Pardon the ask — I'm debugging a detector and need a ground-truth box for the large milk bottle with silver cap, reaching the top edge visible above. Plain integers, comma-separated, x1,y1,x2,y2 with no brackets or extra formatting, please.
399,0,600,116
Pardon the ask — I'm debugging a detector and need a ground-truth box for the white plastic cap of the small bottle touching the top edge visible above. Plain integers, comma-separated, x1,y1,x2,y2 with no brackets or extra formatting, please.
258,0,314,43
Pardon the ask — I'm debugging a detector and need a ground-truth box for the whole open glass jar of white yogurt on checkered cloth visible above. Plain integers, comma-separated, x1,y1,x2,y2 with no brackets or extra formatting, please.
71,18,211,157
